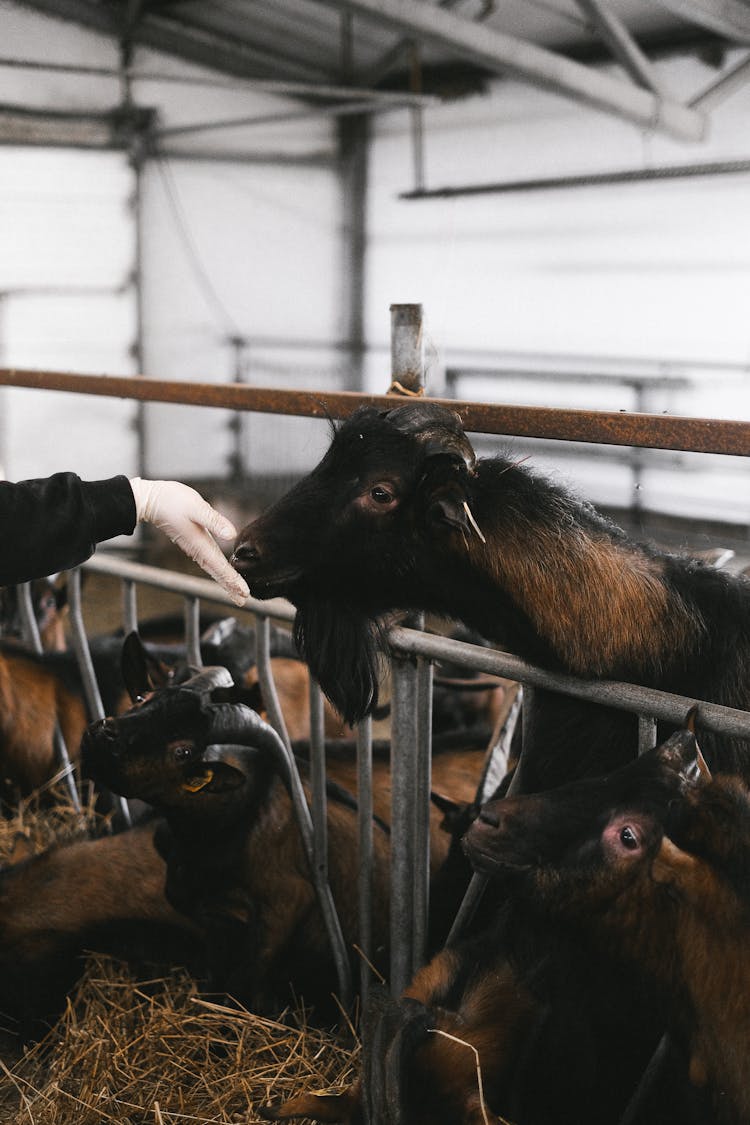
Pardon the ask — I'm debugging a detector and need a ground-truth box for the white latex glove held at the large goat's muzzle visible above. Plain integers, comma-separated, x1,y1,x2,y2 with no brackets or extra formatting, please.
130,477,250,605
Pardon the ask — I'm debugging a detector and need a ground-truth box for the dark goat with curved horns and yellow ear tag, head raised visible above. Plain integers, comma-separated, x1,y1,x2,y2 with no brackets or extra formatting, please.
82,638,390,1017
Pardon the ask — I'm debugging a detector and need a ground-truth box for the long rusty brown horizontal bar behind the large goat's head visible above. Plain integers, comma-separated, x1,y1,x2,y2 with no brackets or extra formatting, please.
0,368,750,457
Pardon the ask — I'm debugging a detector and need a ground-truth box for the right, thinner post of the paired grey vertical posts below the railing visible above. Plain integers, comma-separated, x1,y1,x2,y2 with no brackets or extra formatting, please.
412,658,432,973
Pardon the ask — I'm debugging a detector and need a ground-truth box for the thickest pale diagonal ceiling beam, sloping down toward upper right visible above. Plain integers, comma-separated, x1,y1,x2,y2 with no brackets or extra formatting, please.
314,0,705,141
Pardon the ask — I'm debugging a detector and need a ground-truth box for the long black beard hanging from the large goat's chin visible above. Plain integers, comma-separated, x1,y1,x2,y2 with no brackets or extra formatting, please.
293,599,382,726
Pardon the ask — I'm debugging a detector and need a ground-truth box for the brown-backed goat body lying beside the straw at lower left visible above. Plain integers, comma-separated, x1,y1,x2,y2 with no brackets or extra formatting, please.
0,822,204,1041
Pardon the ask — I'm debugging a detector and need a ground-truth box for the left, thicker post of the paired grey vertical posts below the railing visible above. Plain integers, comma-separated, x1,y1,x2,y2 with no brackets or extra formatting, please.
390,657,417,997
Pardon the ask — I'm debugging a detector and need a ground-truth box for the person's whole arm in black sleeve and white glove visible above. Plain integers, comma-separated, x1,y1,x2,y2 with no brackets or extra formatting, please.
0,473,250,605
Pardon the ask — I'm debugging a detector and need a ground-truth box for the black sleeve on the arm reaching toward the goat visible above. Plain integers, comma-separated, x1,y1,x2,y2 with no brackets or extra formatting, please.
0,473,136,586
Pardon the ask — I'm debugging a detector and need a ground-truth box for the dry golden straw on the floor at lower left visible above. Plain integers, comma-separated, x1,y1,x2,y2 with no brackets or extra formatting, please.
0,803,358,1125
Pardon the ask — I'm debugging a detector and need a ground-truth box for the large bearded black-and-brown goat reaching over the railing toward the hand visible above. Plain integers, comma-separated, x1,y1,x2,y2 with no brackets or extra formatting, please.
233,402,750,791
